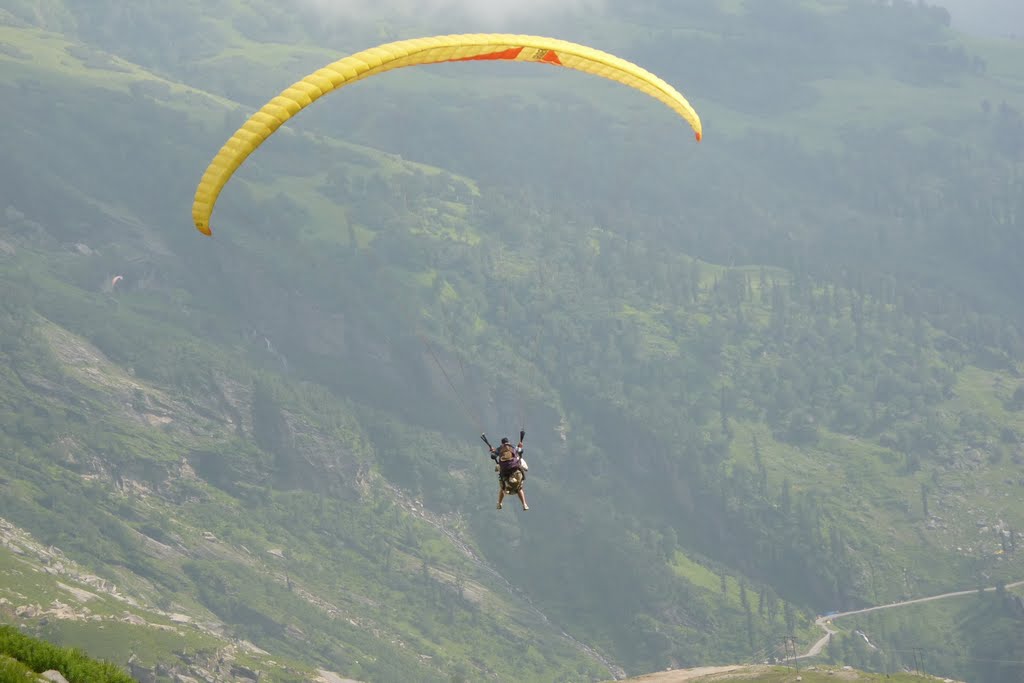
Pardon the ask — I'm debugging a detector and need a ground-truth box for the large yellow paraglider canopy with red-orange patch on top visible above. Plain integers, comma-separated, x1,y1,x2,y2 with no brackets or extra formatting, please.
193,34,701,234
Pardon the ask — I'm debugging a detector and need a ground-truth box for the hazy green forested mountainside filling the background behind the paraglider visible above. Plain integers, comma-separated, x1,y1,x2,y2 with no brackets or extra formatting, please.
0,0,1024,681
